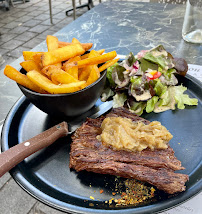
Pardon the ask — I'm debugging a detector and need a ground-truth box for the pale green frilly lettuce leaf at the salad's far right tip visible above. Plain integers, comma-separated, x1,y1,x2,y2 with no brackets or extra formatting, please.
175,85,198,109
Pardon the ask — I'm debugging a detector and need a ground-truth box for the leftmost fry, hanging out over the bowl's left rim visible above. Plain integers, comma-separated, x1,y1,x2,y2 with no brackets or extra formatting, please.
4,65,46,94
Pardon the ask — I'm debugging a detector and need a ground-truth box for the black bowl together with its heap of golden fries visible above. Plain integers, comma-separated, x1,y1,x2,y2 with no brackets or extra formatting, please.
4,35,118,117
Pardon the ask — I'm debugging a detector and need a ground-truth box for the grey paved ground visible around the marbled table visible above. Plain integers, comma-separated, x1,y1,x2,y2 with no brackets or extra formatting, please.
0,0,186,214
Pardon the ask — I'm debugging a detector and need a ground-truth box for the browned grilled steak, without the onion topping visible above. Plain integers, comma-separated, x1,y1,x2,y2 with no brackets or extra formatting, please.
69,108,188,194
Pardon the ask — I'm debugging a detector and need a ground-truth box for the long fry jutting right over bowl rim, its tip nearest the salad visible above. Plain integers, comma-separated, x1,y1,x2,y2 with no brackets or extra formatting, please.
74,51,117,68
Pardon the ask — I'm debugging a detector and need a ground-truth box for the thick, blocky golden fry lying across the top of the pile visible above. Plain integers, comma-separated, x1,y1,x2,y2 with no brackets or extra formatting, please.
41,44,85,67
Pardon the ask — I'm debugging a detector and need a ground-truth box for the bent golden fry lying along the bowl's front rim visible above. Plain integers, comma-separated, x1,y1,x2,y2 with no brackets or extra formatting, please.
27,71,85,94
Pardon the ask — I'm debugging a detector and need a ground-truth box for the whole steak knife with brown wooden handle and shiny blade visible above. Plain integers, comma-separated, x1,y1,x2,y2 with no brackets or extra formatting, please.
0,101,113,177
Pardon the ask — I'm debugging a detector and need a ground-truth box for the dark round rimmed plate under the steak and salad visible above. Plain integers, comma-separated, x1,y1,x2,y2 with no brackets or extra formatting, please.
2,76,202,214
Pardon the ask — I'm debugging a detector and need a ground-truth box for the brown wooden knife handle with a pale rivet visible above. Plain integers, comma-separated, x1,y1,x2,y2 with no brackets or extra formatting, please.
0,122,68,177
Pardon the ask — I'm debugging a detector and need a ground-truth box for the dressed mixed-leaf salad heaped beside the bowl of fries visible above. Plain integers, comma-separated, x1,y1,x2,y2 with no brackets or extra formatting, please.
102,45,198,115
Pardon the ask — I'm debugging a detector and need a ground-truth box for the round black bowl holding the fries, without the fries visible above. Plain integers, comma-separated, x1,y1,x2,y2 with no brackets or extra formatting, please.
18,69,107,117
